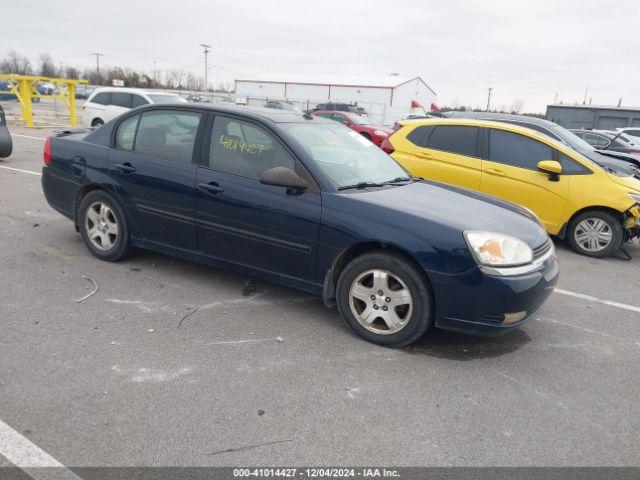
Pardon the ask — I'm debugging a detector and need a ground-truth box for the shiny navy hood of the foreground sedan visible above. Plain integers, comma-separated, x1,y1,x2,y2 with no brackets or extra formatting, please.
341,181,548,248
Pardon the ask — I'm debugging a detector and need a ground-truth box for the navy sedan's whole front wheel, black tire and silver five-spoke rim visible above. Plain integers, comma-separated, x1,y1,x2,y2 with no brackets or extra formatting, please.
336,250,433,347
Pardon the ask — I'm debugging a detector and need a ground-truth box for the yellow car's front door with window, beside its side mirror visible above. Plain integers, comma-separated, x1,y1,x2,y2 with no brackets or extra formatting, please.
480,128,571,234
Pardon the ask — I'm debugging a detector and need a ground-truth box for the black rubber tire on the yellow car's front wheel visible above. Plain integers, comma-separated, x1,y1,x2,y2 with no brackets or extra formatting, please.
567,210,624,258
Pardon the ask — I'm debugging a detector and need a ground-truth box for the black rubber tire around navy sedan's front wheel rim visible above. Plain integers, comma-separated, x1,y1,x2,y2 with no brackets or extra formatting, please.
336,250,434,347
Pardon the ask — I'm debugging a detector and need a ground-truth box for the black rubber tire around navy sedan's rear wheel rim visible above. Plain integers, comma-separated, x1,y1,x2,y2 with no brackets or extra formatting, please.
77,190,131,262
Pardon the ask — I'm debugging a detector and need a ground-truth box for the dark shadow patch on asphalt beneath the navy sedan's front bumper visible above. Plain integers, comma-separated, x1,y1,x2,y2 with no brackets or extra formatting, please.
402,328,531,361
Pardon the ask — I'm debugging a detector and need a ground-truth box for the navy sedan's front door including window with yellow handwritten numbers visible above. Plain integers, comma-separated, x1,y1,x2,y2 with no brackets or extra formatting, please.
196,116,320,282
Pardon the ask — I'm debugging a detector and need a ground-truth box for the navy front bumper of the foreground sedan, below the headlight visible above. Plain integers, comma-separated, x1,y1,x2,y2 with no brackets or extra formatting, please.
429,254,560,335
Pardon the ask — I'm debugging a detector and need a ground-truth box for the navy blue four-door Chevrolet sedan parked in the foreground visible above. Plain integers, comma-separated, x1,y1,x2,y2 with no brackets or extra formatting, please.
42,105,559,347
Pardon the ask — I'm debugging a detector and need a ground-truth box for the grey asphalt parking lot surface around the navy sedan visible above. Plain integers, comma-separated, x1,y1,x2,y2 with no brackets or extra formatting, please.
0,121,640,466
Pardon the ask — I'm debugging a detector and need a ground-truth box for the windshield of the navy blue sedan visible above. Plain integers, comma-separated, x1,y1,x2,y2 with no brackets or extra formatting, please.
283,123,410,189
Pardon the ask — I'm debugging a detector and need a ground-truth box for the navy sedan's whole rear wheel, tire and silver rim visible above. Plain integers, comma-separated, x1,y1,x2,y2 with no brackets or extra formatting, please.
78,190,131,262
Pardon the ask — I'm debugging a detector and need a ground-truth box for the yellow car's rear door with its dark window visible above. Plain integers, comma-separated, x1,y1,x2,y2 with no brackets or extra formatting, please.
392,125,482,190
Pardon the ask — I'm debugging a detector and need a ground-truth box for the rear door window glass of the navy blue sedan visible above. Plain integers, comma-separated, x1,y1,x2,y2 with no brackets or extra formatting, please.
134,110,201,163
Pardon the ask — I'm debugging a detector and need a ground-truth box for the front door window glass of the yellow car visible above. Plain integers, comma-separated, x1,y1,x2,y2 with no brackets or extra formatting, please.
489,128,553,170
